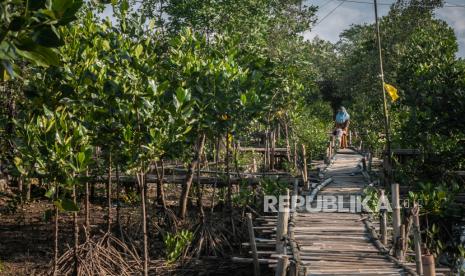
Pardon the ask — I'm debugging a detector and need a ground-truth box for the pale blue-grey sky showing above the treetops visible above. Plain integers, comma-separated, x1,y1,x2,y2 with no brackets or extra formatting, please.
304,0,465,58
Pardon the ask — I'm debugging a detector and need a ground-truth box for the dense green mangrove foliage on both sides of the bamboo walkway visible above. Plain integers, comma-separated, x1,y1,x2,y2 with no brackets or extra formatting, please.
0,0,465,274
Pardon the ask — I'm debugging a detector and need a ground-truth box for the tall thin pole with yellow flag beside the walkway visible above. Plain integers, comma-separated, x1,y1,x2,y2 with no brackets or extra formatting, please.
373,0,392,186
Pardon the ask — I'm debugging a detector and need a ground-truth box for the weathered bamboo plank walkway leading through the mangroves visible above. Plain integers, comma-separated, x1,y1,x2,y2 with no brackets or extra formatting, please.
294,149,407,276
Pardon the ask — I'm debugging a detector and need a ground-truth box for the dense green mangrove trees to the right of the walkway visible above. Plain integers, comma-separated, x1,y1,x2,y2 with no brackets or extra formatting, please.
322,1,465,266
